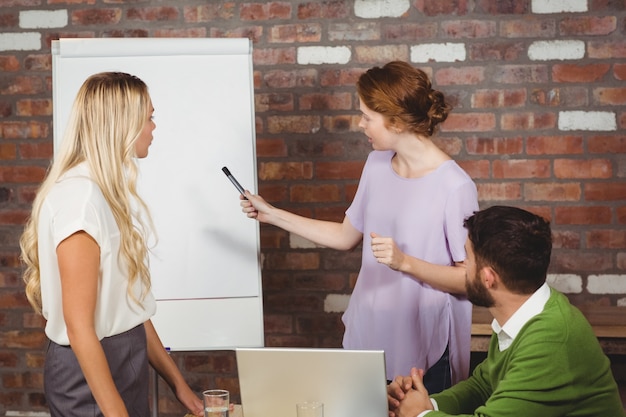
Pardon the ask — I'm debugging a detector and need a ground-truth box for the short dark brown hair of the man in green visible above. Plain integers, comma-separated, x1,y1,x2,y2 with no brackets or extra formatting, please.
464,206,552,294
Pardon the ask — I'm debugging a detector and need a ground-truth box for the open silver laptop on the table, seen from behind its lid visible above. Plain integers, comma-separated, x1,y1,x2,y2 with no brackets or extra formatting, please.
236,348,388,417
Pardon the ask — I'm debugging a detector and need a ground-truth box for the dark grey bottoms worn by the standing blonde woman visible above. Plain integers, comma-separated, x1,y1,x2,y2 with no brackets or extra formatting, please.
44,324,150,417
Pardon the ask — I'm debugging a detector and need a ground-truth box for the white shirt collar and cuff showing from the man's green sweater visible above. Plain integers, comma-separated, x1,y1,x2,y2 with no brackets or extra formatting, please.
417,282,550,417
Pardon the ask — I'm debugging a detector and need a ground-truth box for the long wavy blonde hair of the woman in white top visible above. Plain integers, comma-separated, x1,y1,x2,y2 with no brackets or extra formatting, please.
20,72,152,313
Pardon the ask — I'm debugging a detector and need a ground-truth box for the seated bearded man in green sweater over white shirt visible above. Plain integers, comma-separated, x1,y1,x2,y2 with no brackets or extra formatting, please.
388,206,625,417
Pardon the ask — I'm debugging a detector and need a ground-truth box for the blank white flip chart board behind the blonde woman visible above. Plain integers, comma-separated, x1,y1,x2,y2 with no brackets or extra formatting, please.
52,38,263,350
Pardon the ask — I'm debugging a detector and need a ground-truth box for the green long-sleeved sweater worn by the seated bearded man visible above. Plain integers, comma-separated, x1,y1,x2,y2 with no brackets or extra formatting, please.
427,290,625,417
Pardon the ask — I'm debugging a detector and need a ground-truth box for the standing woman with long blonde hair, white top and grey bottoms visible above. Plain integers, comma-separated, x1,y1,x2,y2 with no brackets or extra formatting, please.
20,72,203,417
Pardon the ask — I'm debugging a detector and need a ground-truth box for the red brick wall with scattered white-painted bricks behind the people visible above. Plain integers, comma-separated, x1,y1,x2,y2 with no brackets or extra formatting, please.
0,0,626,416
